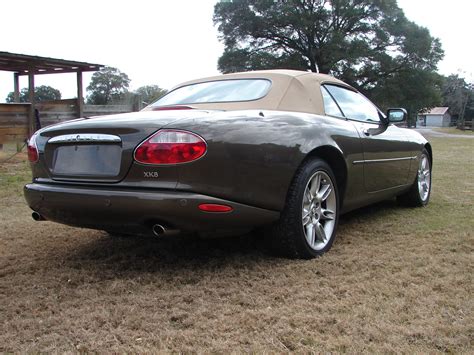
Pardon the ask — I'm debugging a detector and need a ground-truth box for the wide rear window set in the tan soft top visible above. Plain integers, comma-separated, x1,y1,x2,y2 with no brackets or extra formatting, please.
151,79,272,107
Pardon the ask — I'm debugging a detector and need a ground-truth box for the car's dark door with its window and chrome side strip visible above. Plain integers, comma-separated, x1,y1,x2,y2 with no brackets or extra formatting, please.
323,85,412,193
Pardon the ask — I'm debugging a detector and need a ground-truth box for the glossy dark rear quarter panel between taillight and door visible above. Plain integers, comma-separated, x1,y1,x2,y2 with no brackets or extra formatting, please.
166,110,363,211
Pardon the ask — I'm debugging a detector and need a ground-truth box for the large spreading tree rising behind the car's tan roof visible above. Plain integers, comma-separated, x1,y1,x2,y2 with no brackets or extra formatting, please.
214,0,444,115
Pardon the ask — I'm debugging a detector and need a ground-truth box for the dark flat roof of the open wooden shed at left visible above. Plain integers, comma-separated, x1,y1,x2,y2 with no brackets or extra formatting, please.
0,52,105,75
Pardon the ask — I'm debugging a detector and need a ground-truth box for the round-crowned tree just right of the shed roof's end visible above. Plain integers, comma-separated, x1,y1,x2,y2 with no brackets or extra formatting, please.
87,67,130,105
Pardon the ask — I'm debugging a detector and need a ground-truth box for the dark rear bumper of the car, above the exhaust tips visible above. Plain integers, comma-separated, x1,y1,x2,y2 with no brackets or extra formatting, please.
24,183,279,232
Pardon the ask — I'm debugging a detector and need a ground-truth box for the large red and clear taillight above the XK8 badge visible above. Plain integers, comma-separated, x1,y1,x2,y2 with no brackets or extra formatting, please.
134,129,207,164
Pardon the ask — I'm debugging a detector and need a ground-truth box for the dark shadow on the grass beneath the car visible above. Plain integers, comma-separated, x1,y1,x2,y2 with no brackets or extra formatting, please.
55,200,400,275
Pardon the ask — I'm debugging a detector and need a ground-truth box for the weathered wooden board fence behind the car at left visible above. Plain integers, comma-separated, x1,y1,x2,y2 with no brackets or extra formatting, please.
0,99,138,148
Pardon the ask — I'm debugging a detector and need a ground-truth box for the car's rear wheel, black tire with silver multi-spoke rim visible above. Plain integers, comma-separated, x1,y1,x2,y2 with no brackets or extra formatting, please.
267,159,339,259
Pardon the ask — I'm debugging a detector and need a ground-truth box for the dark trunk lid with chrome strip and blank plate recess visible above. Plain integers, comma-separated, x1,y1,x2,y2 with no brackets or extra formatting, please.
38,110,212,183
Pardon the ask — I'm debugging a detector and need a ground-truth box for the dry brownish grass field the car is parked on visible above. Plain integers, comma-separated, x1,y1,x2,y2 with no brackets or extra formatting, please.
0,138,474,353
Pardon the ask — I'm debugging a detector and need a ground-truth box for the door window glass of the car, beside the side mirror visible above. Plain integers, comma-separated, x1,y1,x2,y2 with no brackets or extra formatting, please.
324,85,380,122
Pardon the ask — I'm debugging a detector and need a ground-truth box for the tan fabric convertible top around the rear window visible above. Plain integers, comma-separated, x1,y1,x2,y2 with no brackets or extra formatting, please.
155,69,355,114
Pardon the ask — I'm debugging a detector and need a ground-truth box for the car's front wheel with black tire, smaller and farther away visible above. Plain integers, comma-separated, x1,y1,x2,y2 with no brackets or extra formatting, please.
397,149,432,207
